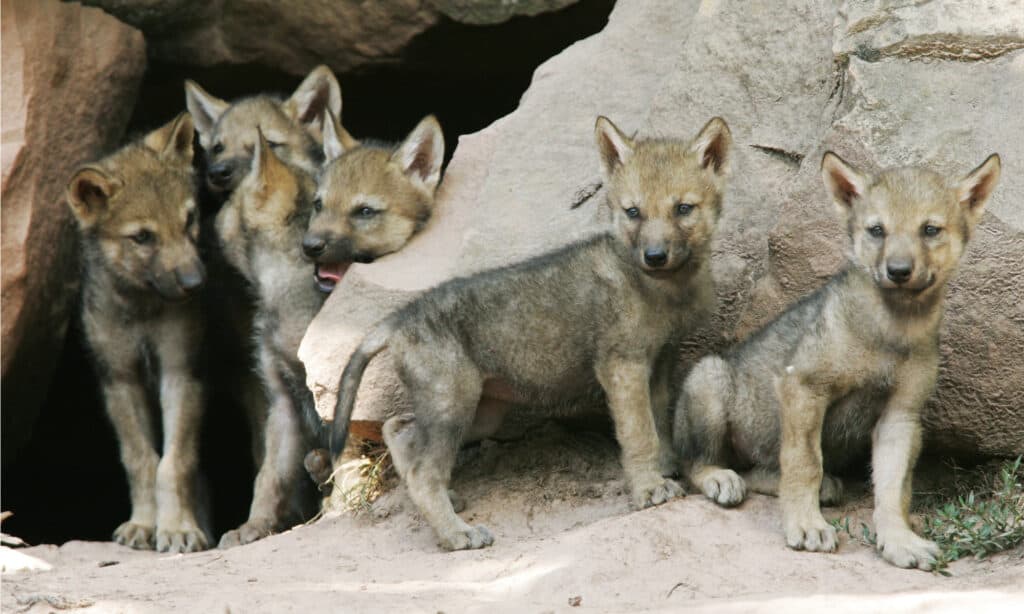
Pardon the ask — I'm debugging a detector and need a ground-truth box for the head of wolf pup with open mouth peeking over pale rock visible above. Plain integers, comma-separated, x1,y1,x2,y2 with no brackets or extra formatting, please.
302,114,444,293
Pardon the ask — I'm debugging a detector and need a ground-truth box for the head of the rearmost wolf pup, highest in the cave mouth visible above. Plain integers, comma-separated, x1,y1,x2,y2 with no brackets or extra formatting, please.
185,65,341,196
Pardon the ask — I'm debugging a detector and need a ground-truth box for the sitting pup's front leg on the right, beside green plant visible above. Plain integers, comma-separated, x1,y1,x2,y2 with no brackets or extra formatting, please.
871,362,939,570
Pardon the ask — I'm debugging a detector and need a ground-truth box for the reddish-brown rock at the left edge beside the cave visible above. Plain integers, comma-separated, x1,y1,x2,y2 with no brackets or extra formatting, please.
2,0,145,458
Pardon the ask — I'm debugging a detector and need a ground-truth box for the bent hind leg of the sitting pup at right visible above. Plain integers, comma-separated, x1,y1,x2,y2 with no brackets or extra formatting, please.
675,356,746,507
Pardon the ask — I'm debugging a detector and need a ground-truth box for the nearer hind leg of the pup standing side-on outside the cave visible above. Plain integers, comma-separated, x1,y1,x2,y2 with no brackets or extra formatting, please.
383,350,494,551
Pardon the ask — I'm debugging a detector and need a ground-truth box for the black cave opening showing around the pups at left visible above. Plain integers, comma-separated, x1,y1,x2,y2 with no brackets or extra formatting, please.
2,0,614,544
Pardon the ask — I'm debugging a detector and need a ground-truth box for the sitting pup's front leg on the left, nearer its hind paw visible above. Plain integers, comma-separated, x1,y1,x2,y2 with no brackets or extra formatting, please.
776,372,837,552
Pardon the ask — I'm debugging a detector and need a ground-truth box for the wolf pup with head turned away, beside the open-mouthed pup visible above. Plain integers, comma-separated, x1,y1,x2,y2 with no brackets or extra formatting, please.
215,129,326,547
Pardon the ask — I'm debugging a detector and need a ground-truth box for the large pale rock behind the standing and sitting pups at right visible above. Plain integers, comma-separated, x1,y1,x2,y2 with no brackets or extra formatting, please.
300,0,1024,454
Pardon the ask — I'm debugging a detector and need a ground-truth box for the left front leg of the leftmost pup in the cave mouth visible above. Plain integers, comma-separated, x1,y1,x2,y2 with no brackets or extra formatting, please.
102,372,160,550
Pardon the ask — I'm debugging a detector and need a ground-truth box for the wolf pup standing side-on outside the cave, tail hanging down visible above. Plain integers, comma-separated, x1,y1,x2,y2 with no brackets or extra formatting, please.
331,118,731,550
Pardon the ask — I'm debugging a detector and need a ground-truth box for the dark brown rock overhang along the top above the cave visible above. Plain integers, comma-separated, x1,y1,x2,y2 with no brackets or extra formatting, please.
84,0,577,75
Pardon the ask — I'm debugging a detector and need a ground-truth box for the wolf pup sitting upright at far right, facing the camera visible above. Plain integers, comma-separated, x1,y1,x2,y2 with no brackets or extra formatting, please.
675,152,999,569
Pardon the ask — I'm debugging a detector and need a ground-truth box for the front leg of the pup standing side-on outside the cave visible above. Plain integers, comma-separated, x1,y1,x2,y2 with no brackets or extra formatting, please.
596,358,683,508
